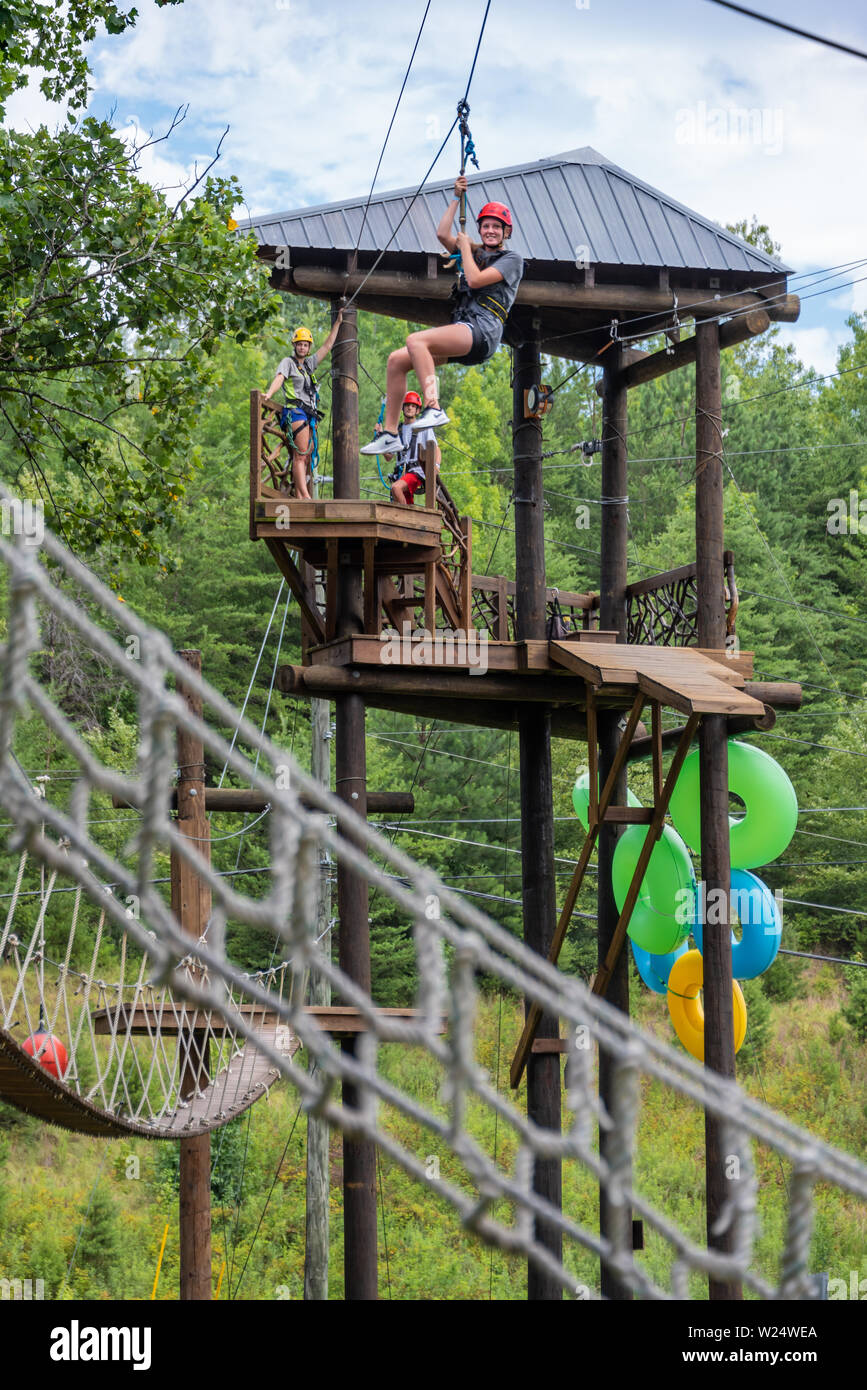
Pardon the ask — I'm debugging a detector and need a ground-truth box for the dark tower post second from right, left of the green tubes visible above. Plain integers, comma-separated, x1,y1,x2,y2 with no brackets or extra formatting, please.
596,345,632,1301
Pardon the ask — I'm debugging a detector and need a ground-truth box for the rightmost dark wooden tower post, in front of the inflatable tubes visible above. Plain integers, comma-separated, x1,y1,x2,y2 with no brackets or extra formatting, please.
696,321,741,1300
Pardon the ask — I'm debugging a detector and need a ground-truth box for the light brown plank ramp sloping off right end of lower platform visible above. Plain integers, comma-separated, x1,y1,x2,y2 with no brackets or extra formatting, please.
547,642,764,716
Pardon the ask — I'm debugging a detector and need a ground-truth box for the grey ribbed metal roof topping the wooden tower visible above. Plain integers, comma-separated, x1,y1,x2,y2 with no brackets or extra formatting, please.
242,146,789,275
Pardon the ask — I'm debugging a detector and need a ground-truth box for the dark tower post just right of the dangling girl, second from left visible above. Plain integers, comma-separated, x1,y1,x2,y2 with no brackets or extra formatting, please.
513,336,563,1301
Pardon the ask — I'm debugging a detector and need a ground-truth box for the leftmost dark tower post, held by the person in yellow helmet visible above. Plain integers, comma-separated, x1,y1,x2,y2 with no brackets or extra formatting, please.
329,298,378,1301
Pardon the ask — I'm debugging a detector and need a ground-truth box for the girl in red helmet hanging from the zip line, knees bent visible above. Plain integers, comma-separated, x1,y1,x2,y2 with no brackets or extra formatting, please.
361,174,524,453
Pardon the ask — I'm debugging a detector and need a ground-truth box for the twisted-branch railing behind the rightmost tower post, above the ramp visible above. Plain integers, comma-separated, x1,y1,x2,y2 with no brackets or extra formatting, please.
627,550,738,646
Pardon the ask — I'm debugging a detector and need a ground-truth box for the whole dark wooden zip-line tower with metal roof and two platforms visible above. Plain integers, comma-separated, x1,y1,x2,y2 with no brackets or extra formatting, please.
240,149,800,1300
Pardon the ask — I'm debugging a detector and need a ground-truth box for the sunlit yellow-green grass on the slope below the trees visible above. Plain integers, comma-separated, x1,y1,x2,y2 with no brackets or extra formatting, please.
0,967,867,1301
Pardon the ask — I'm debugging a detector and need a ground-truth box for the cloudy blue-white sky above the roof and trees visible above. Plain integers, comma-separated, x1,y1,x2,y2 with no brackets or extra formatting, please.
10,0,867,371
